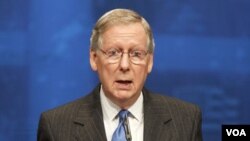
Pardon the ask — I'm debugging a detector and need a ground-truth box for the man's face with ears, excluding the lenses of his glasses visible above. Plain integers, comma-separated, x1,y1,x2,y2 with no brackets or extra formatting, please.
90,23,153,108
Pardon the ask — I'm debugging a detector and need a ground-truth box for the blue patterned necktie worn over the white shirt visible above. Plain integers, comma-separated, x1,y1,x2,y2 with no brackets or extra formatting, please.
112,110,128,141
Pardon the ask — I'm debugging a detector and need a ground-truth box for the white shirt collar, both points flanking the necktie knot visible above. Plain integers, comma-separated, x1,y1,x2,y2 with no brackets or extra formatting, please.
100,87,143,122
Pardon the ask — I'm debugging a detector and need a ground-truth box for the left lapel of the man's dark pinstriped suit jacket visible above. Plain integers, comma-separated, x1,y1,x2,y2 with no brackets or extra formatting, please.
74,87,106,141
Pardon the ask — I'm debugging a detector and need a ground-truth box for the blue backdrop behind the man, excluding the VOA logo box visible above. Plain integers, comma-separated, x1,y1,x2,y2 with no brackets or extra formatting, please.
0,0,250,141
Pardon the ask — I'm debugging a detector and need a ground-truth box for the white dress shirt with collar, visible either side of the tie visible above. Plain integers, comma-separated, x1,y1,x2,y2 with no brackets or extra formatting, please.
100,87,144,141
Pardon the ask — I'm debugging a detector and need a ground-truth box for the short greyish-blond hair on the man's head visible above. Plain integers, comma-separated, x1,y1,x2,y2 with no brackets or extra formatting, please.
90,9,155,53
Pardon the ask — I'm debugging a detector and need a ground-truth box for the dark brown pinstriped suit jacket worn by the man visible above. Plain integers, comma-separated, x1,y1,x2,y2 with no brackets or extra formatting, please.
37,86,202,141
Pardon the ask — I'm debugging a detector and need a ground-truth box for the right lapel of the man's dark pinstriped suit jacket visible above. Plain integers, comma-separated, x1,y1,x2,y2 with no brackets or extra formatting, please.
143,89,173,141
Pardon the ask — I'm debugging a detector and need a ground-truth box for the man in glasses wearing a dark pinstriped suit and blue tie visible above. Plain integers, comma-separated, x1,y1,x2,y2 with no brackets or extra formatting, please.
37,9,202,141
